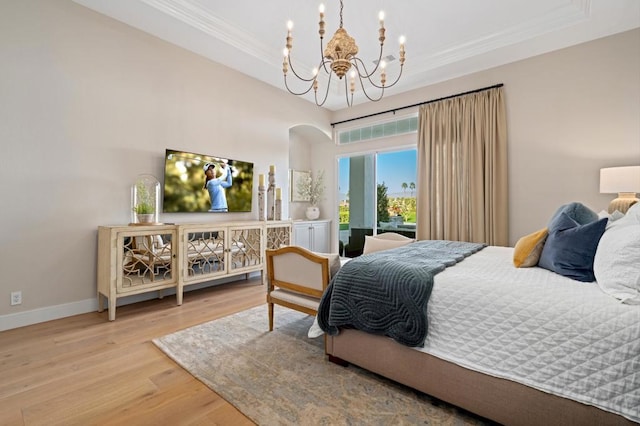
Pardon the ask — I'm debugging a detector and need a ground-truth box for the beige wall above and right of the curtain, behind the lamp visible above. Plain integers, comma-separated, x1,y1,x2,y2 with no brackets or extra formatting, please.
326,29,640,245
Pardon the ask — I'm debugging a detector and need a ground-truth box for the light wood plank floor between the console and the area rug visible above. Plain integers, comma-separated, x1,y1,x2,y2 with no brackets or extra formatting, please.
0,278,267,426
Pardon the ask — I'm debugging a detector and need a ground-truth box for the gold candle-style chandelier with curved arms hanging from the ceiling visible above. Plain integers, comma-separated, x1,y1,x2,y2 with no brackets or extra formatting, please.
282,0,405,106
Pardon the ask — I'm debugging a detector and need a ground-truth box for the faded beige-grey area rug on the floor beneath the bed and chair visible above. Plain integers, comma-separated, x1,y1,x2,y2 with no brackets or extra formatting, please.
153,305,486,425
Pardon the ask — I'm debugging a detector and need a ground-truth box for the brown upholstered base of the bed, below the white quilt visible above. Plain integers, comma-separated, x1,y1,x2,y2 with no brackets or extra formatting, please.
325,329,635,426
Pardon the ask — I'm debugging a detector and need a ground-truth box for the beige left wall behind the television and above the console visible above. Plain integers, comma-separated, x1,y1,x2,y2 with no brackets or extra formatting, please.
0,0,329,330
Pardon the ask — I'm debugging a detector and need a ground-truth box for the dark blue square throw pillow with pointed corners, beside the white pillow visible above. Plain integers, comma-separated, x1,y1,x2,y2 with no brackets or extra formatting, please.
538,212,608,282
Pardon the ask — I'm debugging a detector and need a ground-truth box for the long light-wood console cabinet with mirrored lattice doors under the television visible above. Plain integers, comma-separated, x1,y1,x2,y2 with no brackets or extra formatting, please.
97,221,291,321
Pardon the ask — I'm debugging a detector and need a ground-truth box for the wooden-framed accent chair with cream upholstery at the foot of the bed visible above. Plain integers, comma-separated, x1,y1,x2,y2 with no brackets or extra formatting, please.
266,246,330,331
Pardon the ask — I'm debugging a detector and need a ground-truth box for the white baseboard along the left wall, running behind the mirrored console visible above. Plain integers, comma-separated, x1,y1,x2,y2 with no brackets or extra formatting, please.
0,272,260,331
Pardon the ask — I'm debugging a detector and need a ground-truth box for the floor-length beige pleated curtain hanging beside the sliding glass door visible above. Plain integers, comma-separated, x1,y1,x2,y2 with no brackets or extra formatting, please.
416,87,509,246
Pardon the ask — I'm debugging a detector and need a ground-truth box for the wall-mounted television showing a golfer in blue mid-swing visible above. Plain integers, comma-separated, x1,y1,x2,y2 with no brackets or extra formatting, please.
162,149,253,213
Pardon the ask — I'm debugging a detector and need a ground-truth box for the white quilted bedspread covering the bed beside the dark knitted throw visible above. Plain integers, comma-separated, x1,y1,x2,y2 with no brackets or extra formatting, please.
416,247,640,422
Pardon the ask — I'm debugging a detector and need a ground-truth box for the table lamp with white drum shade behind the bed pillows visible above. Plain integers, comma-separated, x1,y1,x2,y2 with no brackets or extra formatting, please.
600,166,640,213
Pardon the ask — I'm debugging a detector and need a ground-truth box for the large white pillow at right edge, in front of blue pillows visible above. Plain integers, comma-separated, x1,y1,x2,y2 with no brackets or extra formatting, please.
593,215,640,304
